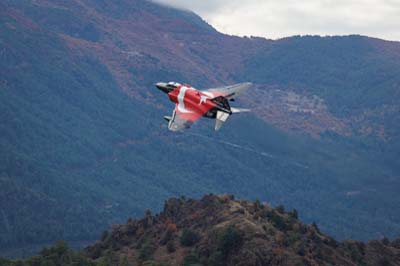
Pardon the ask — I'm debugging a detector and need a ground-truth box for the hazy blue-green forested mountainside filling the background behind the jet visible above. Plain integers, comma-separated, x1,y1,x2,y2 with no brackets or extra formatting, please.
0,0,400,257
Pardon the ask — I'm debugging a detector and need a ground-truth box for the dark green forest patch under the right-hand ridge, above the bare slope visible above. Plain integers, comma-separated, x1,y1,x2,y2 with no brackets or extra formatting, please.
242,36,400,115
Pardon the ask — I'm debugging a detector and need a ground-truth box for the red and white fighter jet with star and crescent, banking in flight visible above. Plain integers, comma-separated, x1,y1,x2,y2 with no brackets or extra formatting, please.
156,82,251,131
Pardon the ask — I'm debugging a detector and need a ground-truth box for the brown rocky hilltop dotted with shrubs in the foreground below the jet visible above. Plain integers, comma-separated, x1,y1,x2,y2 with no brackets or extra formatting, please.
85,195,400,266
